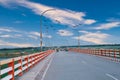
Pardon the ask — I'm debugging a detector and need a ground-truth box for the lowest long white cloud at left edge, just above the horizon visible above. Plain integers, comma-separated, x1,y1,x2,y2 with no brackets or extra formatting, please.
0,40,35,47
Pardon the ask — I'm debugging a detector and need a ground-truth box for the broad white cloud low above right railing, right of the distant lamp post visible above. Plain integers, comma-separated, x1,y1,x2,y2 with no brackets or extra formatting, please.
74,31,110,44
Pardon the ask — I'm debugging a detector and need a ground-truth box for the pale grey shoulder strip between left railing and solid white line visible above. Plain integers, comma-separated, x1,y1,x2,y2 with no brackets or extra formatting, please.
15,53,55,80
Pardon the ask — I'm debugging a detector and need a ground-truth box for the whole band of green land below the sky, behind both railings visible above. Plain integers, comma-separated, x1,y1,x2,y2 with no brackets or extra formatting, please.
0,44,120,58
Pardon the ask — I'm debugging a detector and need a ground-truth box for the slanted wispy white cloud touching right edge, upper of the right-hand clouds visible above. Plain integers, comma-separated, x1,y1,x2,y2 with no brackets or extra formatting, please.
95,22,120,30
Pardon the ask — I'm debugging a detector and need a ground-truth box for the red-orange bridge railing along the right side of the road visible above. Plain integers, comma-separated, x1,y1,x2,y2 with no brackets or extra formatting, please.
69,48,120,61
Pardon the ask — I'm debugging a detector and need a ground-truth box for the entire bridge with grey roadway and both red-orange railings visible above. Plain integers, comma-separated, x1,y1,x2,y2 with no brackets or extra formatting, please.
0,48,120,80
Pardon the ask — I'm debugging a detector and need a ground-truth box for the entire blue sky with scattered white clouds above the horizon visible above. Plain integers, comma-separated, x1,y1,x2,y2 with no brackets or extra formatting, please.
0,0,120,48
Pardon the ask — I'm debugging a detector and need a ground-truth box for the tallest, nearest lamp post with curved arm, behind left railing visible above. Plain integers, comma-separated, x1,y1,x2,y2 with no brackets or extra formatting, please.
40,9,56,51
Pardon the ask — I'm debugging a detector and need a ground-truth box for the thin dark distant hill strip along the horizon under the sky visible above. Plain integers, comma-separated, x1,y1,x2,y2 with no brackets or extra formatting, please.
0,44,120,51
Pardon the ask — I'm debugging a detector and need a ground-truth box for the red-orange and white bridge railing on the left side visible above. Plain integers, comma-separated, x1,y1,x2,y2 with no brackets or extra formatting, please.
0,50,54,80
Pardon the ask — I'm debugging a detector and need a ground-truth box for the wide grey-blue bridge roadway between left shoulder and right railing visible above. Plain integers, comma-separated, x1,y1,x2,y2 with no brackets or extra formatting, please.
37,52,120,80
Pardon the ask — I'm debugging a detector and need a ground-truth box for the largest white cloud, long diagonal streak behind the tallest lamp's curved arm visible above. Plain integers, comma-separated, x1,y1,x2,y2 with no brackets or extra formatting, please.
0,0,96,26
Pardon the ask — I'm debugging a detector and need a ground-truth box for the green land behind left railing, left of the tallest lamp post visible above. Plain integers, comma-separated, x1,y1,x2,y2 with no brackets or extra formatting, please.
0,48,39,58
